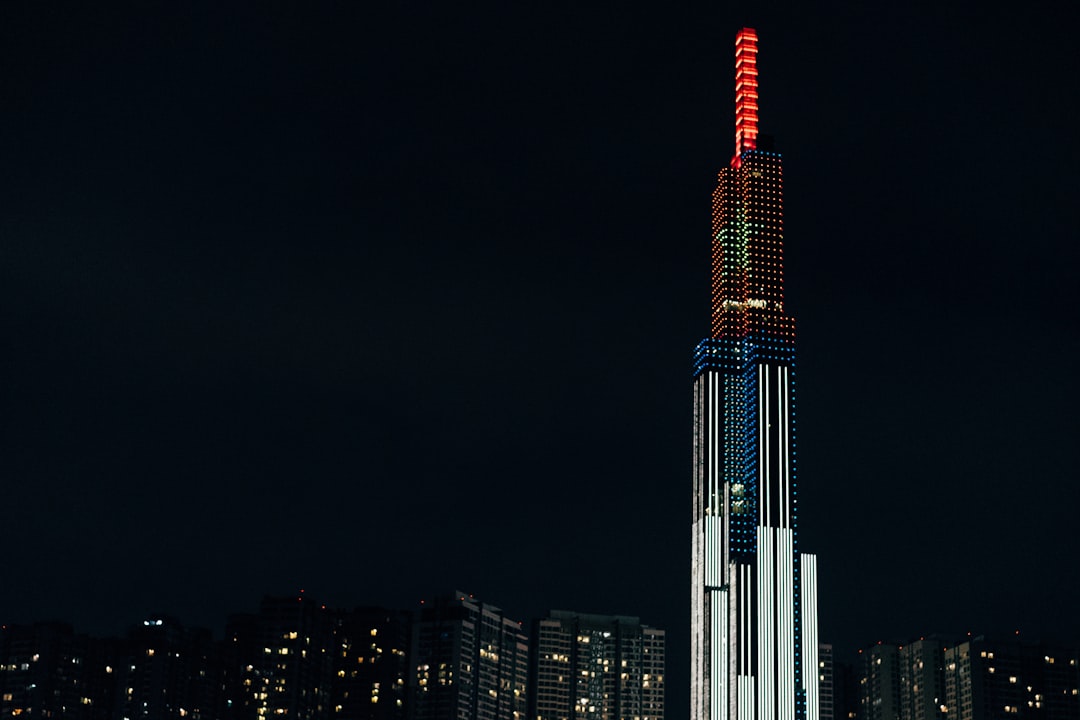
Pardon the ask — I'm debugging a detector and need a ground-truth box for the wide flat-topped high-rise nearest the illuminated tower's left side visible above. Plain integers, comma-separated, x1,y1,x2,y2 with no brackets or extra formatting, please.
528,610,664,720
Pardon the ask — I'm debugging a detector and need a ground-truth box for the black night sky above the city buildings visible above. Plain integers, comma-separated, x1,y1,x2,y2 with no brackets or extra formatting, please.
0,2,1080,717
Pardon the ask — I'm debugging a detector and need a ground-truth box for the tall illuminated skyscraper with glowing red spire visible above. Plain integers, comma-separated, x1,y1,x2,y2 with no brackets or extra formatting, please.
690,28,819,720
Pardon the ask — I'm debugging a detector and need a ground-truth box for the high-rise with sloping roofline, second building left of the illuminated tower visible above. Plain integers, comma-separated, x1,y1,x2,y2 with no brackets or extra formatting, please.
408,593,529,720
